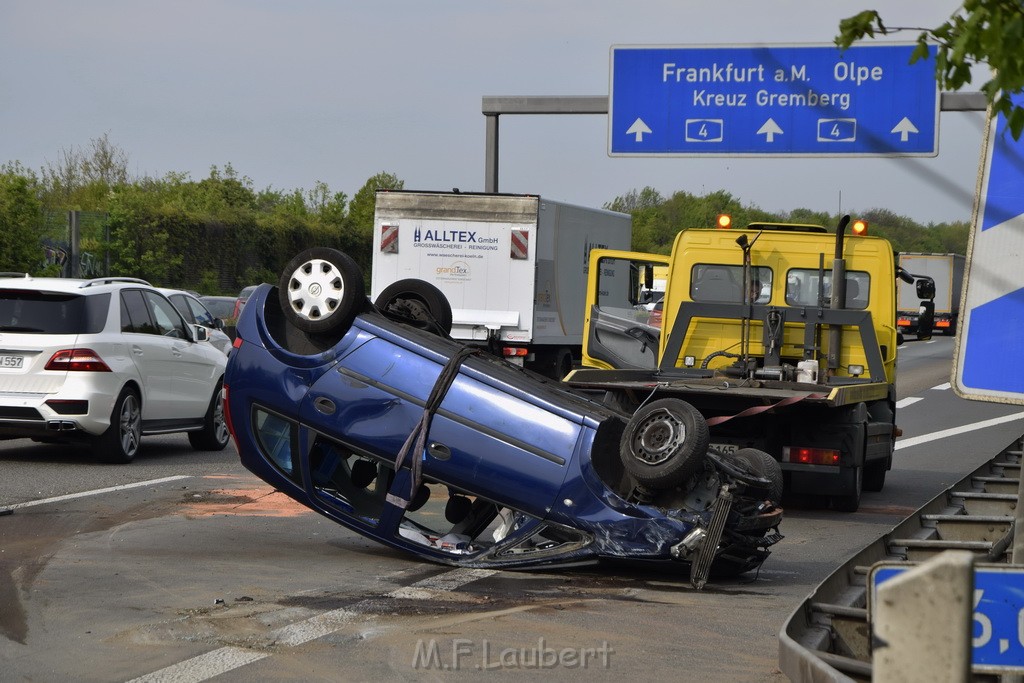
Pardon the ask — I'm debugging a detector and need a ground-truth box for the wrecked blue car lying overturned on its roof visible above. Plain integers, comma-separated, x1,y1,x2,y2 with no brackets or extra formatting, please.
225,248,782,587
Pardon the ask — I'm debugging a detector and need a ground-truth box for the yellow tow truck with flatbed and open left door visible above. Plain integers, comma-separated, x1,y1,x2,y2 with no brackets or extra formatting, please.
565,216,906,512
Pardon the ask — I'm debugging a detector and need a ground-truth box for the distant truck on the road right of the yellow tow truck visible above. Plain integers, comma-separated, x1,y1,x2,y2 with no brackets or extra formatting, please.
896,252,965,339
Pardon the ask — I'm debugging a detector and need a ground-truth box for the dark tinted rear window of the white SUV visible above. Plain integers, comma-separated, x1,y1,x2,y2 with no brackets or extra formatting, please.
0,290,111,335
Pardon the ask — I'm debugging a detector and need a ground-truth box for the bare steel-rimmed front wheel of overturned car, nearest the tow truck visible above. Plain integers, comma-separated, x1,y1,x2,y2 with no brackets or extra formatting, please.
618,398,709,488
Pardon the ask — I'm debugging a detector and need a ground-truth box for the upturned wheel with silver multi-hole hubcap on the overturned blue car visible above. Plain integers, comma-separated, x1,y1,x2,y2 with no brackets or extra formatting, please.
278,247,367,335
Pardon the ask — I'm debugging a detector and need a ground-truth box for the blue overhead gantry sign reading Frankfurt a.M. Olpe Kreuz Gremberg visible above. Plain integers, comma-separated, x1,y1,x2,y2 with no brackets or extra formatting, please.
608,43,939,157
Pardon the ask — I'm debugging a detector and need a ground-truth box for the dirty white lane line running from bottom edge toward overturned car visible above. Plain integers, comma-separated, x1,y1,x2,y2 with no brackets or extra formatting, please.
128,569,497,683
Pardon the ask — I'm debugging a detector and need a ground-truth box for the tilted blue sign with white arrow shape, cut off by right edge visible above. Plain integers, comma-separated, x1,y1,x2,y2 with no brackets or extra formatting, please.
953,90,1024,403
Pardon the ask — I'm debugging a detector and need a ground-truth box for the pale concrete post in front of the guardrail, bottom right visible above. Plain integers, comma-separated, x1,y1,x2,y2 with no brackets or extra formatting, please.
871,550,974,683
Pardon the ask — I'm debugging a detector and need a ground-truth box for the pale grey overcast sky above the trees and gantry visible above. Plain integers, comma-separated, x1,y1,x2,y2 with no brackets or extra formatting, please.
0,0,984,223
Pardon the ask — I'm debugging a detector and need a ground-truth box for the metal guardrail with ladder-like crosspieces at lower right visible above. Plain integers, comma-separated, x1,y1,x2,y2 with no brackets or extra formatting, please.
778,436,1024,683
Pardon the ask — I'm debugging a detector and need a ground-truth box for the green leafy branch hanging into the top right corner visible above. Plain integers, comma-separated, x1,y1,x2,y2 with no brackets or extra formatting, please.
836,0,1024,139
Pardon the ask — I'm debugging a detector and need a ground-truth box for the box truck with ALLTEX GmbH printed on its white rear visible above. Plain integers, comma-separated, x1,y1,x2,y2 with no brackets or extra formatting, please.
370,189,633,379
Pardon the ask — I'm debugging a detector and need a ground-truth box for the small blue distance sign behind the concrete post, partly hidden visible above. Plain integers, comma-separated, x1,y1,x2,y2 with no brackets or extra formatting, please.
868,563,1024,673
